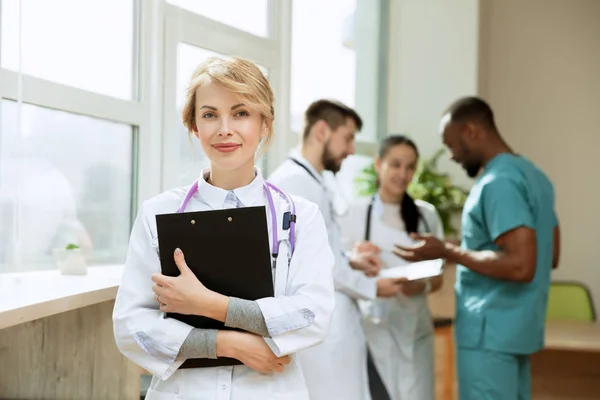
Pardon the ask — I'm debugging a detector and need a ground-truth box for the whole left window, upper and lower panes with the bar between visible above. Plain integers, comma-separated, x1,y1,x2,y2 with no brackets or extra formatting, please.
0,0,143,273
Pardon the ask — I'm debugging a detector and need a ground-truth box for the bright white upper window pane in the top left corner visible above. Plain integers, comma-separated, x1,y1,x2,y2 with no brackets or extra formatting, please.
2,0,134,99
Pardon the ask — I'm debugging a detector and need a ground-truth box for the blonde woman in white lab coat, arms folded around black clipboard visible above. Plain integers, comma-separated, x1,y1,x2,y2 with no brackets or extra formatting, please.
113,58,334,400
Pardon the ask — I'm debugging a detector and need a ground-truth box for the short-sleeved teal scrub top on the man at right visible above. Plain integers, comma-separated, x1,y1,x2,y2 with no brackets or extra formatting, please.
455,153,557,354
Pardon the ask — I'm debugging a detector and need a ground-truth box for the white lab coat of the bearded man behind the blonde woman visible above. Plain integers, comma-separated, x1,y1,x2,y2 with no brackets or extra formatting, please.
269,155,377,400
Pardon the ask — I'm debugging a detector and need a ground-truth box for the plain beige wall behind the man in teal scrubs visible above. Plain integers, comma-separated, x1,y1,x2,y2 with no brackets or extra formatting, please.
480,0,600,311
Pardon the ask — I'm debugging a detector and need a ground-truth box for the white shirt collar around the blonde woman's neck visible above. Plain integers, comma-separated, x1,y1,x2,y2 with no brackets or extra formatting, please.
198,167,265,209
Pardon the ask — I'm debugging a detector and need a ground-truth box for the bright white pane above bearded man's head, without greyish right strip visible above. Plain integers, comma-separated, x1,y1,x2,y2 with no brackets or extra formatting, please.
290,0,356,132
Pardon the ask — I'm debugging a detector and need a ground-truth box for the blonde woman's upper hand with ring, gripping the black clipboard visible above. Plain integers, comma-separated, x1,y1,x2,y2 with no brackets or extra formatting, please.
152,249,229,322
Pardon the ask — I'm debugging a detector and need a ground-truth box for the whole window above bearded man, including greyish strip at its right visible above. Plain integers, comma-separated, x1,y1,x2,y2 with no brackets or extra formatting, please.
290,0,388,147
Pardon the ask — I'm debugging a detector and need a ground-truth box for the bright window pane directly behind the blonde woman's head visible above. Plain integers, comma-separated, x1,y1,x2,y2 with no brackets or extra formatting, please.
174,43,268,185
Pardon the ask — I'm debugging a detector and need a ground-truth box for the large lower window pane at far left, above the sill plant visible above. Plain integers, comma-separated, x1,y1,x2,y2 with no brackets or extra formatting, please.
0,100,133,272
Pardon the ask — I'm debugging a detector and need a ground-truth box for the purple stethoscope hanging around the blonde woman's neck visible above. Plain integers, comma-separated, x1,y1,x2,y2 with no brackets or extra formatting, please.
177,180,296,272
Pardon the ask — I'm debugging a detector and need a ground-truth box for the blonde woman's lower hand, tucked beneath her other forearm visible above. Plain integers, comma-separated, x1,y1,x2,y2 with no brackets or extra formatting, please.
217,331,291,374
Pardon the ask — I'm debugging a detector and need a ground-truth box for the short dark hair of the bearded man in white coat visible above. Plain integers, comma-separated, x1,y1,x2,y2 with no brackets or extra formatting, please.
302,99,362,139
